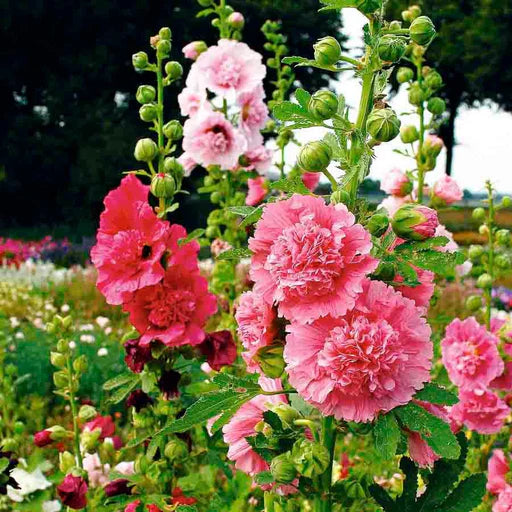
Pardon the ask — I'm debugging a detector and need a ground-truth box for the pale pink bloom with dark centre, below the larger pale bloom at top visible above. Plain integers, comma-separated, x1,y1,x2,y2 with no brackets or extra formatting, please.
183,110,247,169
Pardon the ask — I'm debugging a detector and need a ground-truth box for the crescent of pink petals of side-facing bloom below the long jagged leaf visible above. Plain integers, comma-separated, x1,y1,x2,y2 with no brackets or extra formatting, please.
222,377,288,476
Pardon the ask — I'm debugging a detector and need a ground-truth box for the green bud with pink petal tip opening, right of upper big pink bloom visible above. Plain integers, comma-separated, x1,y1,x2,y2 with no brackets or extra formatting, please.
391,204,439,241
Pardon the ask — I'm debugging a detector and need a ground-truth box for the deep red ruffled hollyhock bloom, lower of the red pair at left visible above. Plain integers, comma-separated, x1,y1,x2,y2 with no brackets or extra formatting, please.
123,264,217,347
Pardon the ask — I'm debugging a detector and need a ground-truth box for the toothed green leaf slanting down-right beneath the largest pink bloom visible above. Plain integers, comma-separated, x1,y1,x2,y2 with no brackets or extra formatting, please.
394,402,461,459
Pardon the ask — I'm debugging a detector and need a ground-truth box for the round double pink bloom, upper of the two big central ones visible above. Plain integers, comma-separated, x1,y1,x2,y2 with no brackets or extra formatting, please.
249,194,378,323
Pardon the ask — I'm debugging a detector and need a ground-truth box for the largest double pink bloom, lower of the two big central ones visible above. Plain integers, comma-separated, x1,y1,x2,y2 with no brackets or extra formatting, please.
284,280,433,422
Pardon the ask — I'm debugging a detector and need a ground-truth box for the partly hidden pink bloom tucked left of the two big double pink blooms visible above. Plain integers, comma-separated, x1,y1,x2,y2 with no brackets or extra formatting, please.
235,292,277,373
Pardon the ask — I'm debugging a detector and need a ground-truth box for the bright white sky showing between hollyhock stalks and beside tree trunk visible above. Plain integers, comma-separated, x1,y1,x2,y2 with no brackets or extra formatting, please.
280,9,512,193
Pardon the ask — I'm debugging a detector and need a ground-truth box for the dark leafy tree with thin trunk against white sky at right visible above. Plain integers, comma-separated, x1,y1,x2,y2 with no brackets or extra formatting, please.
387,0,512,174
